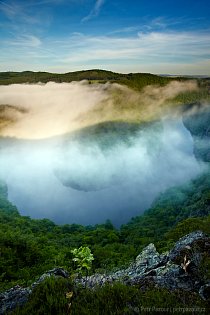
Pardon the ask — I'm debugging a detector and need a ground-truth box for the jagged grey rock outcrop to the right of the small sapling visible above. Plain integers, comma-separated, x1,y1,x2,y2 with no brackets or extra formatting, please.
76,231,210,298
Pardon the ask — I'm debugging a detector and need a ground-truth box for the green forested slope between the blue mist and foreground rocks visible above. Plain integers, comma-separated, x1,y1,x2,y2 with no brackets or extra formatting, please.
0,168,210,290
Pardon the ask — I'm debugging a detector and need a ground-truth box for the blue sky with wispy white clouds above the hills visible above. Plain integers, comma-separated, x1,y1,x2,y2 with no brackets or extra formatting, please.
0,0,210,75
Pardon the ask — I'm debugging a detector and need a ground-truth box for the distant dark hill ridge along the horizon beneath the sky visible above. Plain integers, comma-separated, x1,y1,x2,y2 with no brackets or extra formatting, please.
0,69,210,104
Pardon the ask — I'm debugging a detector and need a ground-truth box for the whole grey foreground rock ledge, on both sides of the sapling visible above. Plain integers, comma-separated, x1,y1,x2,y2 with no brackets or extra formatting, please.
0,231,210,314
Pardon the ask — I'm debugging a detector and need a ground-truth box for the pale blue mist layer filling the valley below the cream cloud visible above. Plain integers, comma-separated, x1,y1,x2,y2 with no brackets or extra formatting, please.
0,120,202,226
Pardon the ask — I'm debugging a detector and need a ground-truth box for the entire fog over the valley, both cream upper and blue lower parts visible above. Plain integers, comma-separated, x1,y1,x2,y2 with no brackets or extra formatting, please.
0,82,203,226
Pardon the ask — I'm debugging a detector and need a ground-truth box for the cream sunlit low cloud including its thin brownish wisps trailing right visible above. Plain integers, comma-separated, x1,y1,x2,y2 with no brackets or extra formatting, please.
0,81,197,139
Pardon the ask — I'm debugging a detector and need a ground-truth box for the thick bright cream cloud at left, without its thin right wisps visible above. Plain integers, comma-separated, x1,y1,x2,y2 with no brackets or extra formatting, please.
0,82,107,139
